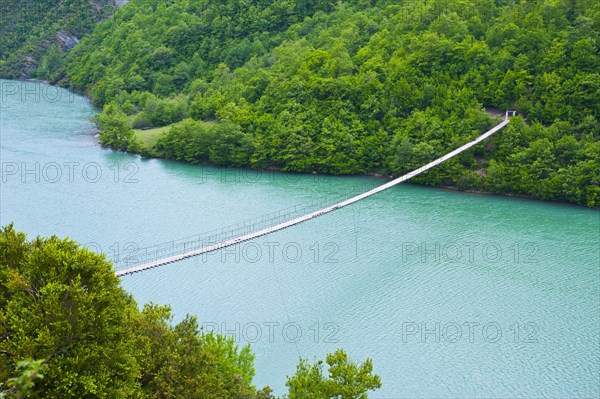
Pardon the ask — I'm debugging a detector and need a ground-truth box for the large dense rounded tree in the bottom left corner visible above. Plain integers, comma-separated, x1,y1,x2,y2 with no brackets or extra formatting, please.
0,226,139,399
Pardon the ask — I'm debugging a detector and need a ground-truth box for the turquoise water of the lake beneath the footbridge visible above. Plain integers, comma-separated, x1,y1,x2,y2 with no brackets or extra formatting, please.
0,81,600,398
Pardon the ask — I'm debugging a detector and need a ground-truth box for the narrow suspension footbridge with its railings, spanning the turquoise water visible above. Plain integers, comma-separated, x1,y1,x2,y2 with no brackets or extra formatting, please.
115,111,515,276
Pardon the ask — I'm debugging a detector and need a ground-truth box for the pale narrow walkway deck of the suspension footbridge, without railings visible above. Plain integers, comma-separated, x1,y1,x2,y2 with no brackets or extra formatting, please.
115,117,509,276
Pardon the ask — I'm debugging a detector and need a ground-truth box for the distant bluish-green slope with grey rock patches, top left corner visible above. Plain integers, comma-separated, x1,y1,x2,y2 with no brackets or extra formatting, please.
0,0,116,79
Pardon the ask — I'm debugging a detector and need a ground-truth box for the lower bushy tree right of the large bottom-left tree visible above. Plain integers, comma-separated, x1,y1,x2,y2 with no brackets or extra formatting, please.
132,305,255,399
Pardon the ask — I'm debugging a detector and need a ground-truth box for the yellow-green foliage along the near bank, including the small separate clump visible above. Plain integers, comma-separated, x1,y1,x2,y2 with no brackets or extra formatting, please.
0,226,381,399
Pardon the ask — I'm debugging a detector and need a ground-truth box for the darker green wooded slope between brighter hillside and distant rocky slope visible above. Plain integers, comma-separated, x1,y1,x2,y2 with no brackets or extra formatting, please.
67,0,333,105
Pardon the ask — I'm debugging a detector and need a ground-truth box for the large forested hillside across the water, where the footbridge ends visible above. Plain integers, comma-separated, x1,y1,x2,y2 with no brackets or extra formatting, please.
5,0,600,206
